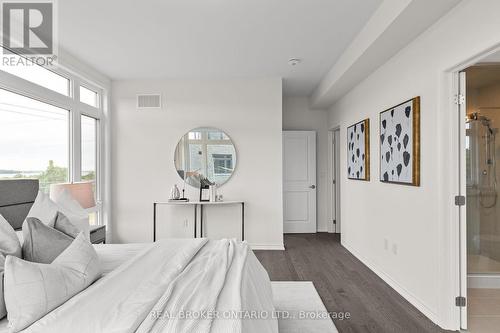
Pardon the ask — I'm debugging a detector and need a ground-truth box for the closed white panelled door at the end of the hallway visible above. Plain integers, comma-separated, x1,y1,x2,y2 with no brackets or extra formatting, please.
283,131,316,233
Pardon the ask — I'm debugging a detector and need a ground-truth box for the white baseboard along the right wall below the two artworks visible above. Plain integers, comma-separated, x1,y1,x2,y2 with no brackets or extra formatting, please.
342,243,442,326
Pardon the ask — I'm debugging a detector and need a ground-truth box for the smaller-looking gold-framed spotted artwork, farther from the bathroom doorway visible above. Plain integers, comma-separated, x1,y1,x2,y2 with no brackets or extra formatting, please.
347,119,370,180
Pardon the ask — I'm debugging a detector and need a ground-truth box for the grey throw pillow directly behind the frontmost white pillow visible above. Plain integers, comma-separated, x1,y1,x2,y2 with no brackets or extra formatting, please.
23,217,73,264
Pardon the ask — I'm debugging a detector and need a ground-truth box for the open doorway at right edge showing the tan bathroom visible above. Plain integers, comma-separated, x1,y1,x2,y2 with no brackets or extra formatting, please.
459,62,500,333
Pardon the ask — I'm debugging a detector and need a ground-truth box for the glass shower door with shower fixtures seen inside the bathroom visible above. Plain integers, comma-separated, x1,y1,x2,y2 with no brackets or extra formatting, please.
466,110,500,274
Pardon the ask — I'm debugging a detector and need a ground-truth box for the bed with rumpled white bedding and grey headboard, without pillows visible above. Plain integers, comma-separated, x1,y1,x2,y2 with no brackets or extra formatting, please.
0,180,278,333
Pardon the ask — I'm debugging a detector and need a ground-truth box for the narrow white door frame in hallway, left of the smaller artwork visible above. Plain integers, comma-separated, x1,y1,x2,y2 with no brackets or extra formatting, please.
327,125,341,233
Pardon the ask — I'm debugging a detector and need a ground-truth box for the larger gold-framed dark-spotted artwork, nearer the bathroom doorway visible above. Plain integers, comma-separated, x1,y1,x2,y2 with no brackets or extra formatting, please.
380,97,420,186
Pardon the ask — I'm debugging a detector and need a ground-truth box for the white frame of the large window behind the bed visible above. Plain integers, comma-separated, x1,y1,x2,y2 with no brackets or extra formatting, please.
0,61,105,224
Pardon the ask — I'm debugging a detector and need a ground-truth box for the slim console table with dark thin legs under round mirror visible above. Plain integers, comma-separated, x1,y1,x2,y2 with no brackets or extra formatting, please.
153,201,245,242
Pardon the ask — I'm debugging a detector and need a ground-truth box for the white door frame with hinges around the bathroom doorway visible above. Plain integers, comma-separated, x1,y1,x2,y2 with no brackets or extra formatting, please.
446,44,500,329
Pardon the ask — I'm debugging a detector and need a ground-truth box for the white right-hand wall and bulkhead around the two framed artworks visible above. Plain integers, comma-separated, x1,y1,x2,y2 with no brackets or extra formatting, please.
329,0,500,329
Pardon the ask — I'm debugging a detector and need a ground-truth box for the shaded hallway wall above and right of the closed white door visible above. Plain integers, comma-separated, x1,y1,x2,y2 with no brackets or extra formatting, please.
283,97,331,232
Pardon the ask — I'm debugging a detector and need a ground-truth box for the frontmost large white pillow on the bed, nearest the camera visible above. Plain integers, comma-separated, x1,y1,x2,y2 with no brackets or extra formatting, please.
4,233,101,332
